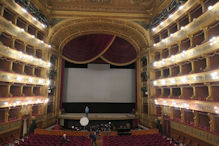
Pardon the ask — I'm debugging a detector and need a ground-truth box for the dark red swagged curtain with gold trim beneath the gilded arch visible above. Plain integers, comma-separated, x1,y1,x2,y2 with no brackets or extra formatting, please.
63,34,137,65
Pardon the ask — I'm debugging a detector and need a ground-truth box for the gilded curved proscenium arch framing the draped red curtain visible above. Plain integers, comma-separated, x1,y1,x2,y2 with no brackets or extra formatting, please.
49,17,148,65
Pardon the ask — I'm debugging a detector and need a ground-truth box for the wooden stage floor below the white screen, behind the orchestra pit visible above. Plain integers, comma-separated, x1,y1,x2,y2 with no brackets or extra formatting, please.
59,113,137,120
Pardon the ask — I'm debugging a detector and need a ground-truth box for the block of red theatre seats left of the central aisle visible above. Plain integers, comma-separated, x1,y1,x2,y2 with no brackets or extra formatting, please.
15,134,91,146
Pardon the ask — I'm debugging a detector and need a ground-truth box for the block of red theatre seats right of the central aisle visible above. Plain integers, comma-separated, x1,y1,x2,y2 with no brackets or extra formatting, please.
103,134,174,146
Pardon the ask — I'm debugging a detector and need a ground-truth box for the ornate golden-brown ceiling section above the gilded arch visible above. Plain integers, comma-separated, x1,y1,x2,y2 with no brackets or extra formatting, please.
33,0,171,23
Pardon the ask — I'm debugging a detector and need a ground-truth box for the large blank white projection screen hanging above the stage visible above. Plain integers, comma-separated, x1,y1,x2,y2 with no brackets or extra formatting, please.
63,64,136,103
